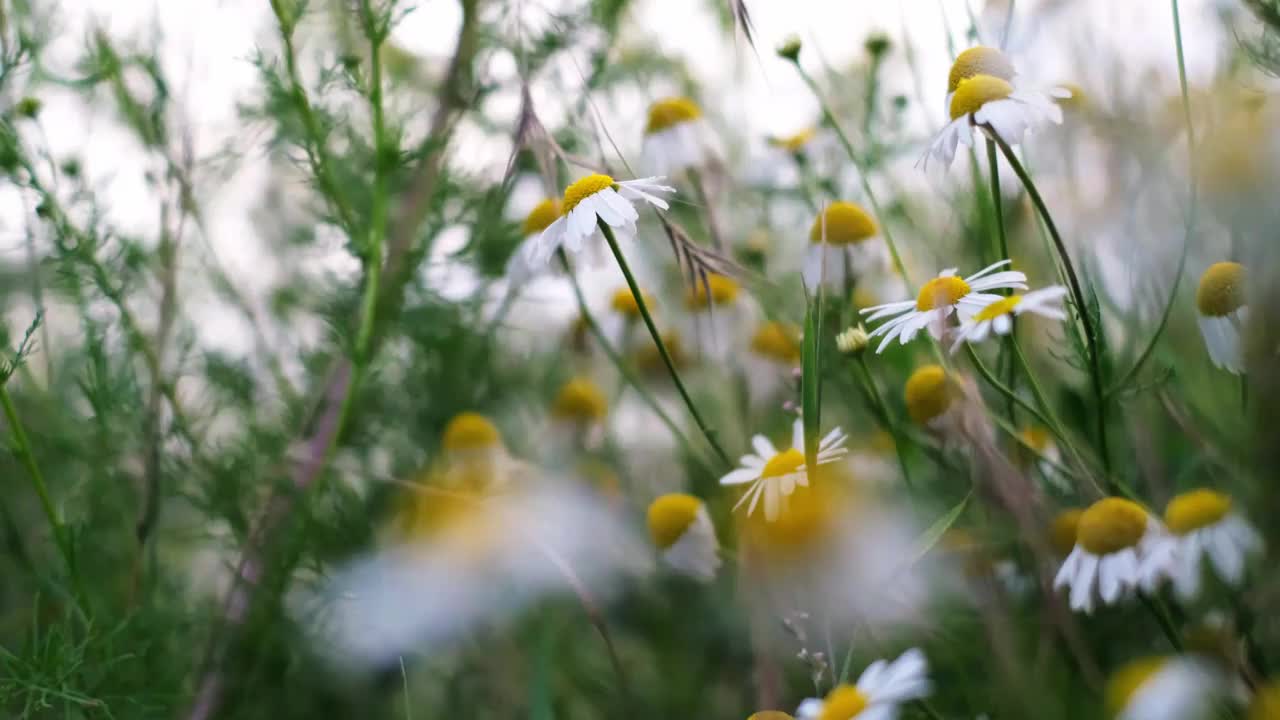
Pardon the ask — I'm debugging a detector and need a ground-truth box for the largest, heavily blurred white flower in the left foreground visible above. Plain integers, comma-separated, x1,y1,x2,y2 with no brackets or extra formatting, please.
307,482,646,667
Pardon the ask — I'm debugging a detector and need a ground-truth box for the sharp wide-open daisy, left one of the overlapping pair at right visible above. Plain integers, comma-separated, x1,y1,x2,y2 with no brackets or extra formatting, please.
861,260,1027,352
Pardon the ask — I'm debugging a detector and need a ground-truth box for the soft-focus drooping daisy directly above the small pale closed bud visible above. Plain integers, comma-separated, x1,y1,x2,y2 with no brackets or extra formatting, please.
804,201,888,288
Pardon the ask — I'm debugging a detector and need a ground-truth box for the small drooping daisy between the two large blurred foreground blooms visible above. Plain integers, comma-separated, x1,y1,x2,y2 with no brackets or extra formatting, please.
646,493,721,583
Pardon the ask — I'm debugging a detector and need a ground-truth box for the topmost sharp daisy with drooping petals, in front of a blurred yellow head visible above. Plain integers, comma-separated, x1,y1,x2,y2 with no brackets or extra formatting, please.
920,74,1070,167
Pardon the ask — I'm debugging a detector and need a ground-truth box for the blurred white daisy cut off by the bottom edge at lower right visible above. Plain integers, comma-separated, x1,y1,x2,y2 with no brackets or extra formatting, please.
1105,655,1224,720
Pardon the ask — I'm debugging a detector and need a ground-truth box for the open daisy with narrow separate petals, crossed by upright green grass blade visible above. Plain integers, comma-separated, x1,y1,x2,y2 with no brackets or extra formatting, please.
721,418,849,521
